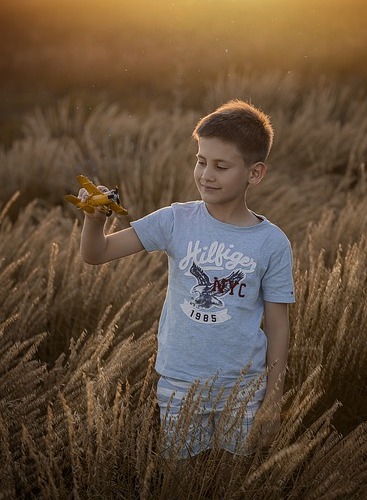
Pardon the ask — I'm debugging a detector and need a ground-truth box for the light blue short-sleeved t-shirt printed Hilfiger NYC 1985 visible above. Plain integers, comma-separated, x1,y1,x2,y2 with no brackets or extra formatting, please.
131,201,294,385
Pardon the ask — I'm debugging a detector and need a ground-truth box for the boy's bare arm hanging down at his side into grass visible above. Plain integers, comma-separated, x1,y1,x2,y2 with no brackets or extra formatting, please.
259,302,289,447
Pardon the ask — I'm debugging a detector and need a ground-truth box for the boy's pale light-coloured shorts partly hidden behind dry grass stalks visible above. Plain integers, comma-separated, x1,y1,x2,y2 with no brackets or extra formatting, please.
157,376,266,459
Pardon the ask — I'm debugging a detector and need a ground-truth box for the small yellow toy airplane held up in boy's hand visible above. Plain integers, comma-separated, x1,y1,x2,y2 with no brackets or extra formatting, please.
65,175,127,216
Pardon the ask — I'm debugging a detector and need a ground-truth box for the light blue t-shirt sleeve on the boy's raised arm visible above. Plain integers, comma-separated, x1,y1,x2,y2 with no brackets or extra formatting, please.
131,207,174,252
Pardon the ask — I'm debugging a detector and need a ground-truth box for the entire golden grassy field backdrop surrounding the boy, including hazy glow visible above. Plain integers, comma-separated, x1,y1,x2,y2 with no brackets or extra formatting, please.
0,0,367,500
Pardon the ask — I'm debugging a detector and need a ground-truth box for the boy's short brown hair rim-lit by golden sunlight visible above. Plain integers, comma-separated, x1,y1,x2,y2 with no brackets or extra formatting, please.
192,99,274,165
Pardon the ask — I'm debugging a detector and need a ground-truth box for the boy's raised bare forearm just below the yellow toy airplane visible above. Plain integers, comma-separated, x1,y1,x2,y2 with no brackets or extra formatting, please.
80,215,107,264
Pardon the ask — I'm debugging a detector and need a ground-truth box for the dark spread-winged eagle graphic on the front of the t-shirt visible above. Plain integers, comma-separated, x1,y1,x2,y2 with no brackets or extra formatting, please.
190,262,244,309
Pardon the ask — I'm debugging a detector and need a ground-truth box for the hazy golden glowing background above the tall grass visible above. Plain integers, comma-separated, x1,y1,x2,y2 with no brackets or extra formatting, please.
0,0,367,145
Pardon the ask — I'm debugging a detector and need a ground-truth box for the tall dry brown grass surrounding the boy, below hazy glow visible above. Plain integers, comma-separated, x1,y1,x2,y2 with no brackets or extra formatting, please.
0,75,367,500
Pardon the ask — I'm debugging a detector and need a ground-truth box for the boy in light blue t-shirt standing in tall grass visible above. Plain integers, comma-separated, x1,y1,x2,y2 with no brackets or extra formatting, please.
79,100,294,458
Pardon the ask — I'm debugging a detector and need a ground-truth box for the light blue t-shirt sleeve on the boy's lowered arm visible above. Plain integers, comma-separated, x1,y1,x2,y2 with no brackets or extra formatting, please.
262,242,295,303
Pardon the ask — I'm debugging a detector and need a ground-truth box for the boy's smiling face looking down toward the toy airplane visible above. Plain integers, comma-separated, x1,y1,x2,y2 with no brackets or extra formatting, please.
194,137,250,207
